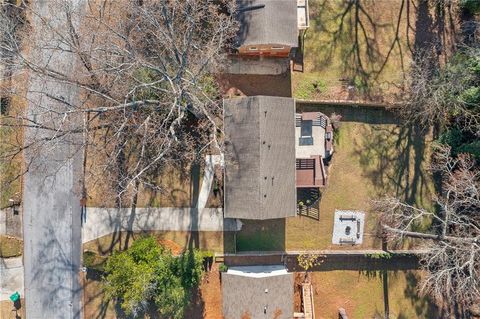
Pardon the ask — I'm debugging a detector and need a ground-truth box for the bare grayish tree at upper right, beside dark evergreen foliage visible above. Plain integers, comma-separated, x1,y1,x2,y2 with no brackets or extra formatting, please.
398,47,480,136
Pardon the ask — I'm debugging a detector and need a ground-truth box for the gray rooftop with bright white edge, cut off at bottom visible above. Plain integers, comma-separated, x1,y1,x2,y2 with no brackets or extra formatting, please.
222,265,294,319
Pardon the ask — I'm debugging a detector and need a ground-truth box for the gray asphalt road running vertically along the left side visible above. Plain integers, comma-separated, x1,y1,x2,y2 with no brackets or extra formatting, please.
23,0,84,319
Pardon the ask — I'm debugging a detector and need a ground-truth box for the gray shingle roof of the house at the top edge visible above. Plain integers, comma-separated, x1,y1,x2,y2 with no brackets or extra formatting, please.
237,0,298,47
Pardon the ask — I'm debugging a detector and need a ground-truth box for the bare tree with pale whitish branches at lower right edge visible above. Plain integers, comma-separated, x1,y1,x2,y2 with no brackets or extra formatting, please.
375,148,480,306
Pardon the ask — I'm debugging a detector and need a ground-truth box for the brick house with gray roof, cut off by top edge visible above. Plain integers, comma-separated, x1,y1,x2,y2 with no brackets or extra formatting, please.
236,0,308,57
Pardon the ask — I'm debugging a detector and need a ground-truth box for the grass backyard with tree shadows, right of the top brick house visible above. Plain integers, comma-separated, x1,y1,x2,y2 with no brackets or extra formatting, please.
292,0,458,101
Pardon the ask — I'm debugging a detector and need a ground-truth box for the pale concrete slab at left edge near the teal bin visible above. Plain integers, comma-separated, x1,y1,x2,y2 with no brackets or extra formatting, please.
0,257,24,301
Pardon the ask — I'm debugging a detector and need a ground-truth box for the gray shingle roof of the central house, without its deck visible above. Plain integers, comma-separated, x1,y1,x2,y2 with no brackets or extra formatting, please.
224,96,296,219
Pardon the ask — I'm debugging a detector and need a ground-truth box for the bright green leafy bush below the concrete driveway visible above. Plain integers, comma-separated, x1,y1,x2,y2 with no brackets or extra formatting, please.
103,237,202,319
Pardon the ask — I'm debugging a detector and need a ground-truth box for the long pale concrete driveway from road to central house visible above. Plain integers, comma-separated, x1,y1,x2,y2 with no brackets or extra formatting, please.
82,207,242,243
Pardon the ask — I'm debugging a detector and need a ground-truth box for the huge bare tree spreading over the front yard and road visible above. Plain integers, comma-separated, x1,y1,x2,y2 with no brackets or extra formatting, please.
0,0,237,205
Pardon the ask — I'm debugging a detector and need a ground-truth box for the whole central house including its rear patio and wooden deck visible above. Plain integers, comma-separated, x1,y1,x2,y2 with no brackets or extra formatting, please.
224,96,333,219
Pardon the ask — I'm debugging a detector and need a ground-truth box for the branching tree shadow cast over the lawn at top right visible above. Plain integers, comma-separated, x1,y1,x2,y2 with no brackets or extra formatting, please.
306,0,457,100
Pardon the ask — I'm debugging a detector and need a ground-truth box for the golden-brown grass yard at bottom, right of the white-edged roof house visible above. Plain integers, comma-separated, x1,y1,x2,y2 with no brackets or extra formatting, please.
312,271,439,319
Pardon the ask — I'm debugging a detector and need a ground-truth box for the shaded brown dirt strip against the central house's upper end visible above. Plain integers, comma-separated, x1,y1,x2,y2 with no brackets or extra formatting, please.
218,72,292,97
